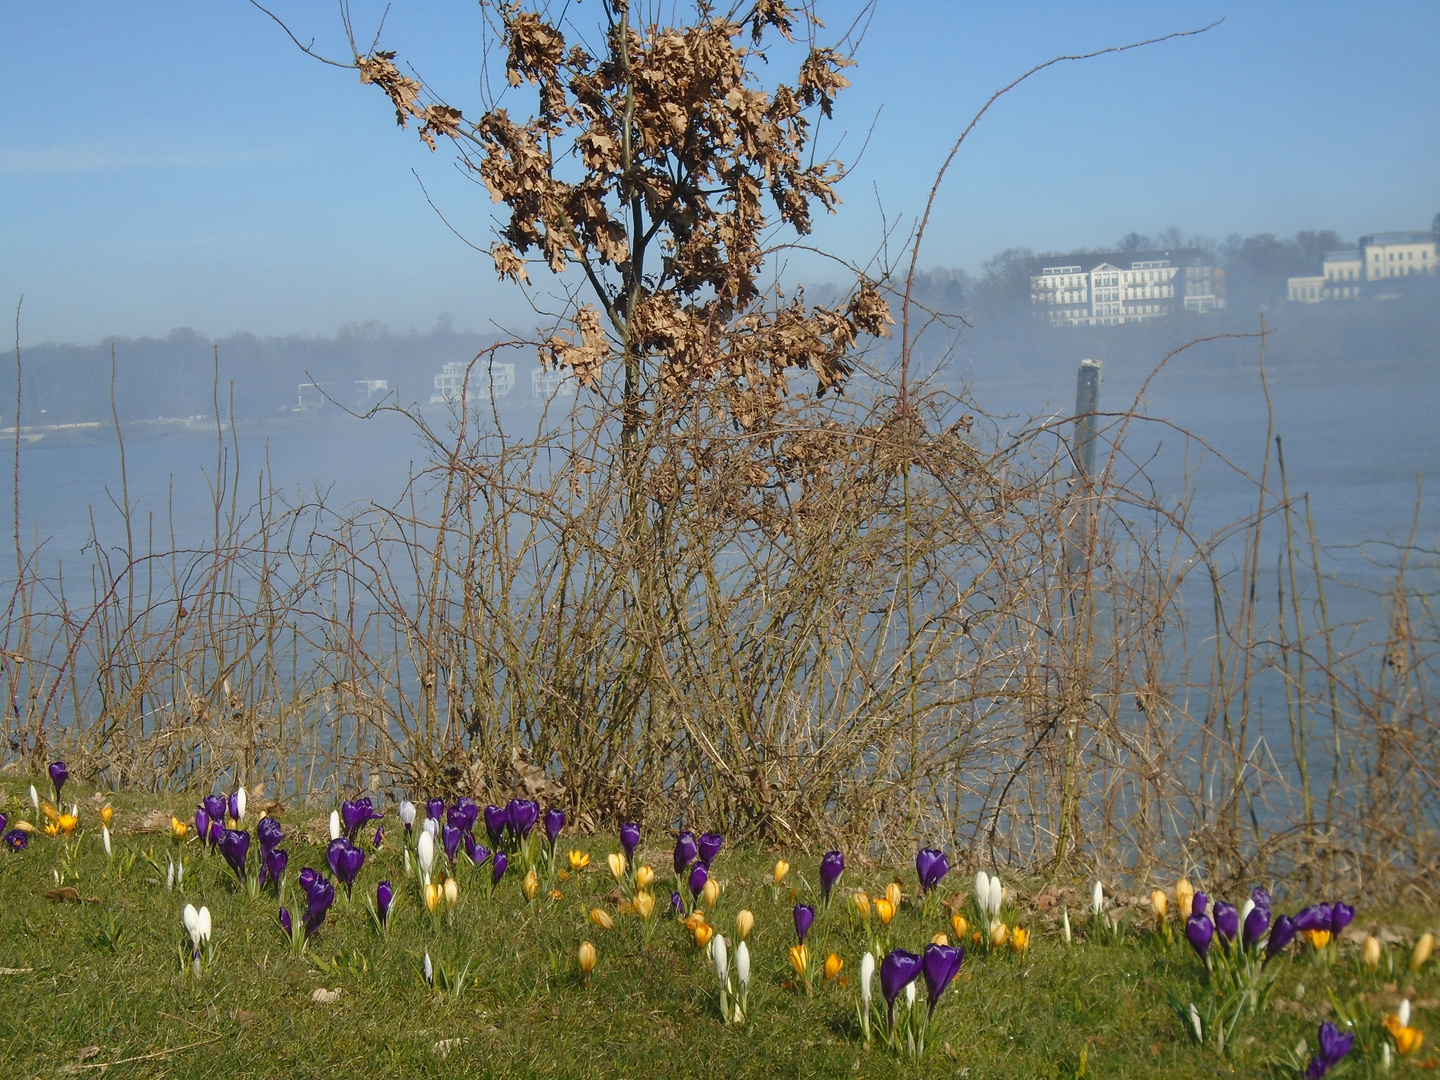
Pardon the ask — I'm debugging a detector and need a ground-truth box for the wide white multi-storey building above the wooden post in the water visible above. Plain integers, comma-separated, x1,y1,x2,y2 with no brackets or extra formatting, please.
1030,248,1225,327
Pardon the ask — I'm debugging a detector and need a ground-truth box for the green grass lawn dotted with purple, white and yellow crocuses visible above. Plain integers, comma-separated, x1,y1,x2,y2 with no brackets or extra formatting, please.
0,786,1437,1080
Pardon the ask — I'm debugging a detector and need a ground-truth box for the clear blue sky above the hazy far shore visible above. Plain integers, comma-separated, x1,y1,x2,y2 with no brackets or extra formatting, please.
0,0,1440,344
